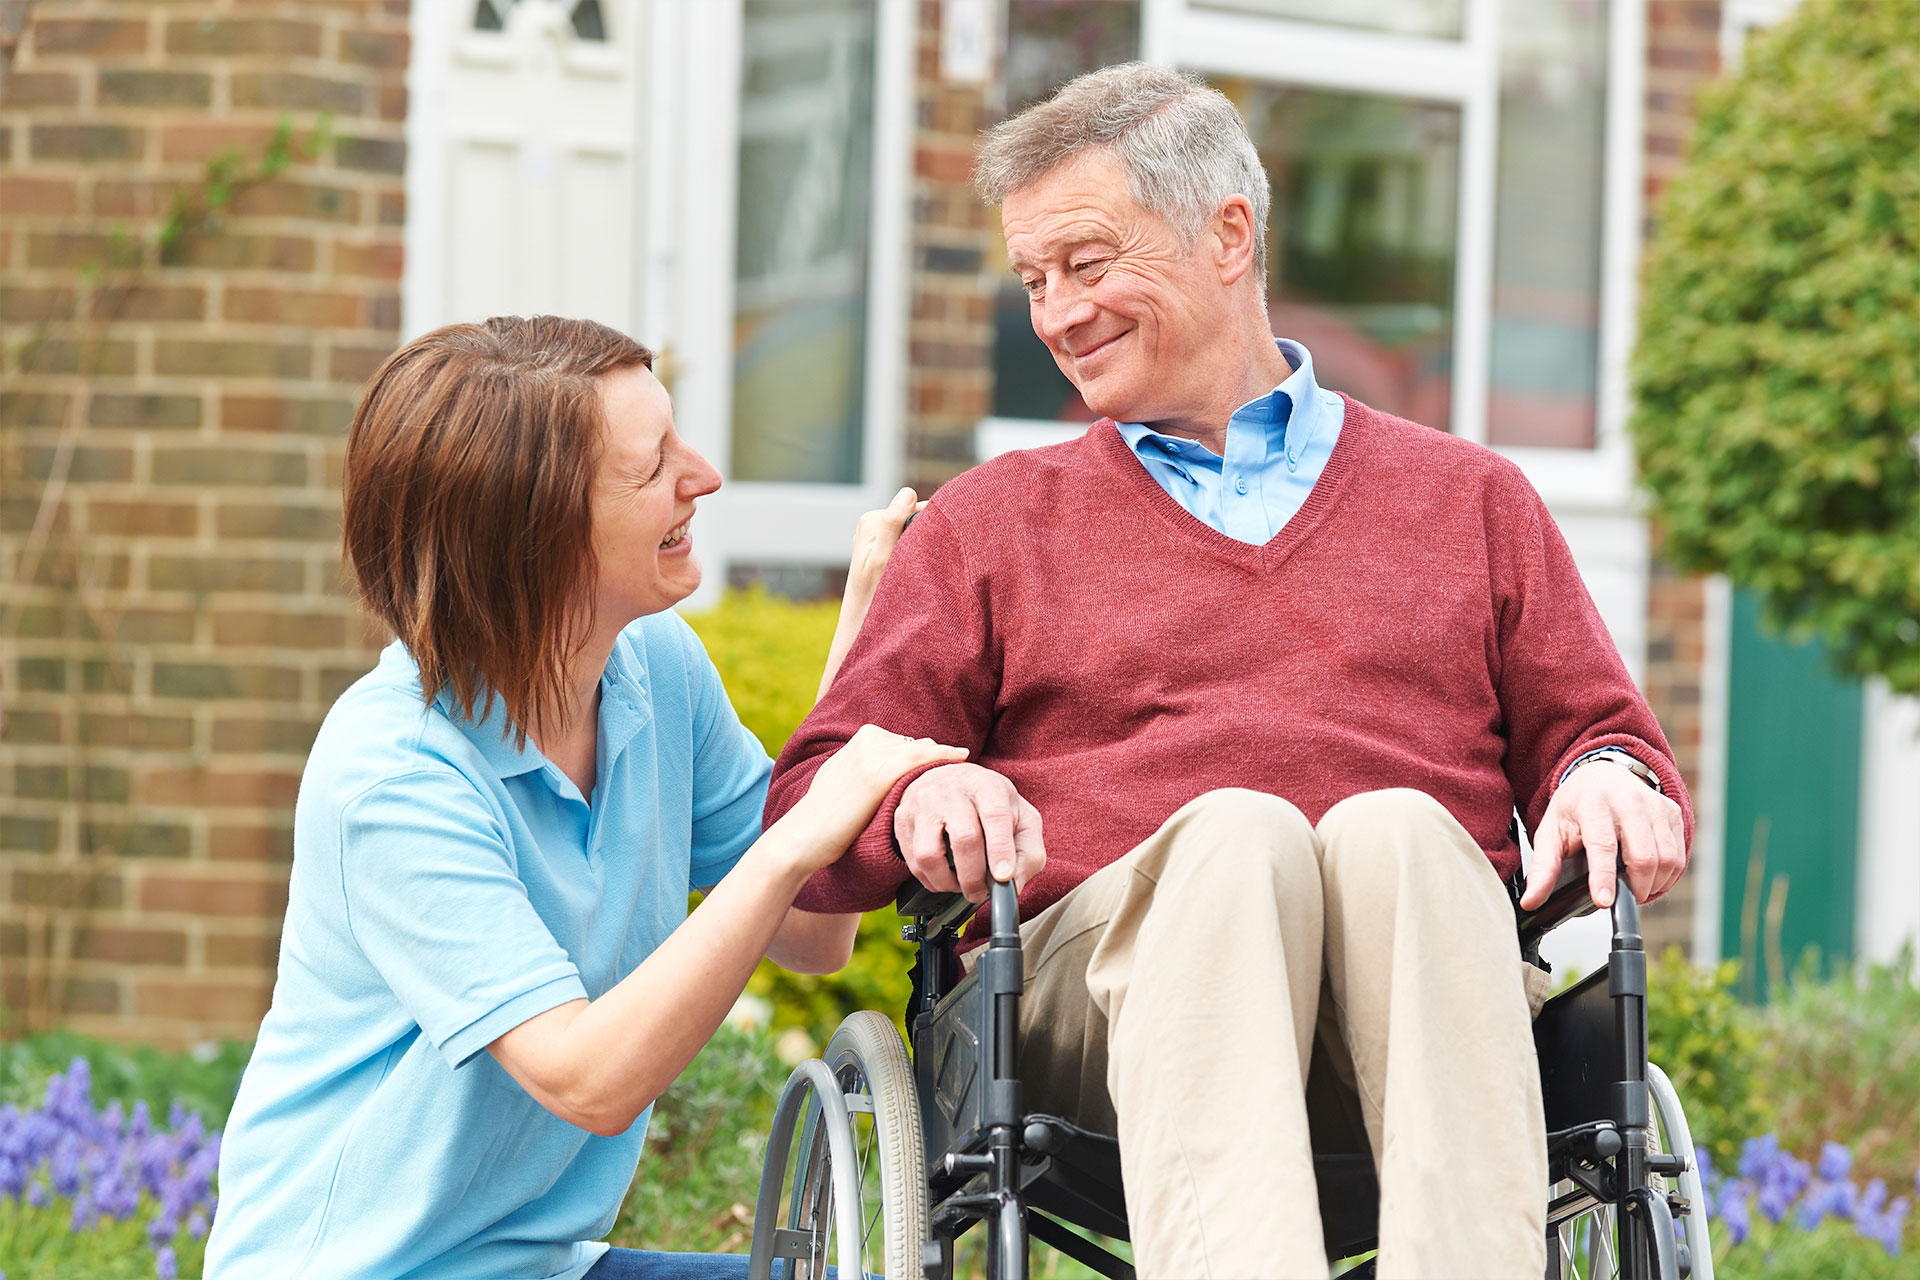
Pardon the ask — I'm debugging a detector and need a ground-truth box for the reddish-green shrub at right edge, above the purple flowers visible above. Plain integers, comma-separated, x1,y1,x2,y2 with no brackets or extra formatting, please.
1758,954,1920,1186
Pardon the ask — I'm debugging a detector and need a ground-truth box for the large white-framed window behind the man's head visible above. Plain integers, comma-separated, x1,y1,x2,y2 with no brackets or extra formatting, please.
993,0,1638,466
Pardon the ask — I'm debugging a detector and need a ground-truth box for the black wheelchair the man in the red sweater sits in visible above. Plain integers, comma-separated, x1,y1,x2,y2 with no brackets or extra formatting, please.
749,844,1713,1280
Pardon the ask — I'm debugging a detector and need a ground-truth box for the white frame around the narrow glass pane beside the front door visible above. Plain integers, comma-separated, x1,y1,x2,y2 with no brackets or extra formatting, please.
668,0,918,608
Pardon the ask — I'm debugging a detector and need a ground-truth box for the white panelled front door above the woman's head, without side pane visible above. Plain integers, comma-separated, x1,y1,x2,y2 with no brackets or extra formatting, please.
405,0,645,336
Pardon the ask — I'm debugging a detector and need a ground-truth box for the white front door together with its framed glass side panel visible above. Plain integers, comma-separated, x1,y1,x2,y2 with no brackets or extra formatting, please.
403,0,914,603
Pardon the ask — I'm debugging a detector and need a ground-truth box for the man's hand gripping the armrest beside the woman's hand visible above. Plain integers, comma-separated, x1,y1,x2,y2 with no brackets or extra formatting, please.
893,764,1046,902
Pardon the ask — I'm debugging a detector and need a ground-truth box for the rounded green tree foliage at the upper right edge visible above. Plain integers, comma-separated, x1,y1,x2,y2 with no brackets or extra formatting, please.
1632,0,1920,693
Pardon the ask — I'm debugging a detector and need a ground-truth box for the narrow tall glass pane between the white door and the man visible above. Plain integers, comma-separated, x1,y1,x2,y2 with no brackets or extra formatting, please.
732,0,877,484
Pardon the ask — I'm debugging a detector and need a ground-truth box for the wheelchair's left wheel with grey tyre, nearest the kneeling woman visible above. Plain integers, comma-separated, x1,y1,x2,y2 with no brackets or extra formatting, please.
747,1011,927,1280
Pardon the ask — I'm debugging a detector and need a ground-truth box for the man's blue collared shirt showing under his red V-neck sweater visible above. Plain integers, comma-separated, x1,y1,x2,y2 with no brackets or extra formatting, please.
1117,338,1346,547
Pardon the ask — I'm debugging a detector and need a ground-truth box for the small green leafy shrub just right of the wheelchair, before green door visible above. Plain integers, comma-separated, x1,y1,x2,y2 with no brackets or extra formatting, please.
1647,946,1770,1167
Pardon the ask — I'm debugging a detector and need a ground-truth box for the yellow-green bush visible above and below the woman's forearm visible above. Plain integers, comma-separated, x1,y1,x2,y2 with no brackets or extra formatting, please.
687,587,912,1048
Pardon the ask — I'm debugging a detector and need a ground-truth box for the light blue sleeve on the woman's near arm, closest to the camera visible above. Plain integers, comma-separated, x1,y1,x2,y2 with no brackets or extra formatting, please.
340,770,588,1067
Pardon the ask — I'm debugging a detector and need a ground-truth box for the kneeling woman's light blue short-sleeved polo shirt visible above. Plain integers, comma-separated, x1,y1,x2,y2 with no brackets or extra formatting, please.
205,614,772,1280
